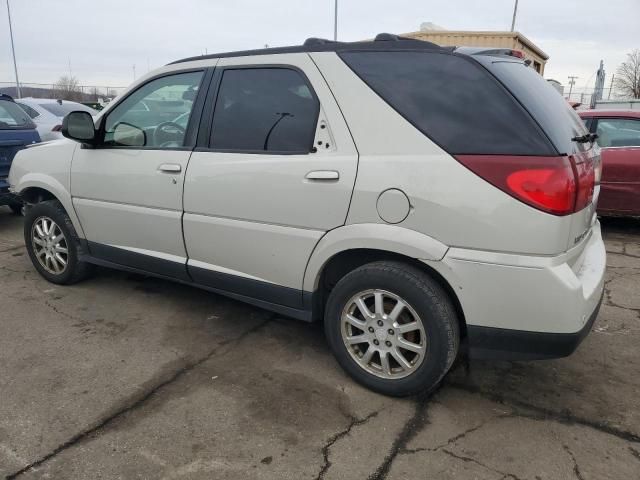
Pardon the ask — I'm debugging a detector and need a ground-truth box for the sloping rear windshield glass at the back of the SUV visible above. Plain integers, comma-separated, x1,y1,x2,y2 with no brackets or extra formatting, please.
476,56,588,154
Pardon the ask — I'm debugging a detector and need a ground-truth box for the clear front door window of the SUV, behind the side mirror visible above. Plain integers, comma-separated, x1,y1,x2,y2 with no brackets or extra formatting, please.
104,72,203,148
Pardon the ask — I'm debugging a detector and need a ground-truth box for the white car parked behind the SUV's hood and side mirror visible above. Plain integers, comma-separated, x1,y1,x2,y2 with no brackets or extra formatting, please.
15,97,98,142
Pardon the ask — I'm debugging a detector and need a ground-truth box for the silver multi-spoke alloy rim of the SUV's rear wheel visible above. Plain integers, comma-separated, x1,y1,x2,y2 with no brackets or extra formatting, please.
340,289,427,379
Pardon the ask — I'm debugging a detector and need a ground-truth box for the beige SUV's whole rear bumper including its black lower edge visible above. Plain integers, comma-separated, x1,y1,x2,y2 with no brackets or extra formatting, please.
430,222,606,359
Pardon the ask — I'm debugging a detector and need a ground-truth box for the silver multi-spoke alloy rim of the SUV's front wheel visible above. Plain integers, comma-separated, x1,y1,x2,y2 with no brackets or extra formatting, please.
31,217,69,275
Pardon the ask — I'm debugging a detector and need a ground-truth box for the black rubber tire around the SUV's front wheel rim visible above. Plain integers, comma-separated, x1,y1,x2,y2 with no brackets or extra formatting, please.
24,200,93,285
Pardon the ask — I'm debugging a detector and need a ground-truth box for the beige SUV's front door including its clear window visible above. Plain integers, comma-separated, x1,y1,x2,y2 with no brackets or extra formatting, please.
71,70,209,280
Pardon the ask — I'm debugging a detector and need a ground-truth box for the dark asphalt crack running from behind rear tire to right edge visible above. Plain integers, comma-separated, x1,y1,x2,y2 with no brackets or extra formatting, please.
447,383,640,443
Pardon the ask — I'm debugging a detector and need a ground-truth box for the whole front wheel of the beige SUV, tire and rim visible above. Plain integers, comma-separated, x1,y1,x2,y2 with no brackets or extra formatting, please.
24,200,91,285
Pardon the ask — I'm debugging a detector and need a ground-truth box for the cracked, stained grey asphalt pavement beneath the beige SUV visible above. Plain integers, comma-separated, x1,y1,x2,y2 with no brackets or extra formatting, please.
0,209,640,480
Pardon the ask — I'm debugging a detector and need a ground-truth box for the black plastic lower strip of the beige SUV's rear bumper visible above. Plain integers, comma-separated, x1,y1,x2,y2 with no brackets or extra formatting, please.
467,288,602,360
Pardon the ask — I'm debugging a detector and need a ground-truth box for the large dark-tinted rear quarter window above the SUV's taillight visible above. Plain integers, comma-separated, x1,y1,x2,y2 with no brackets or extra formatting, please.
340,52,556,155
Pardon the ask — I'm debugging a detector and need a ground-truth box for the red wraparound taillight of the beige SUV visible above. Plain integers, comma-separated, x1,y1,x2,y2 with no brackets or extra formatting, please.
456,155,595,215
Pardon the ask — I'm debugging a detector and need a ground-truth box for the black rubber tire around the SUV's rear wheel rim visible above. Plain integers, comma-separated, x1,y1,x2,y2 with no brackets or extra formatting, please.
324,261,460,397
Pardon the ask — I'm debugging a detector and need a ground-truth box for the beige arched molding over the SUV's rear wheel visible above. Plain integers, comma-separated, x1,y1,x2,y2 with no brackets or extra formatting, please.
302,223,449,292
